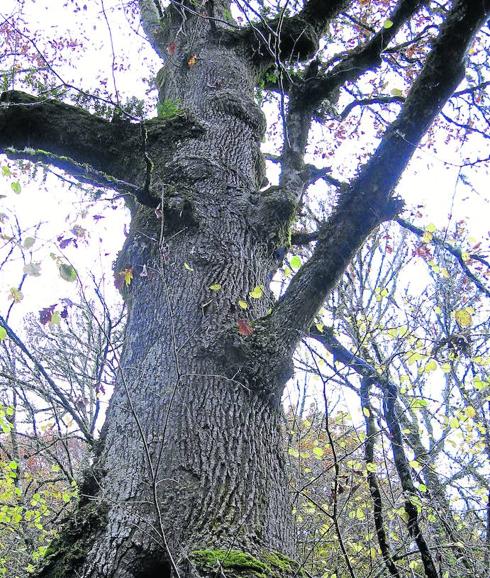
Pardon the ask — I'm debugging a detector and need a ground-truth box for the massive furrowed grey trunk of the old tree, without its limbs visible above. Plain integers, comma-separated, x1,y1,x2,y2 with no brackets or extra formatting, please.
38,4,294,578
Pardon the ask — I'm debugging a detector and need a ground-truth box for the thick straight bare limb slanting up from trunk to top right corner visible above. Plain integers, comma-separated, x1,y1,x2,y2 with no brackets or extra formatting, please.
267,0,490,347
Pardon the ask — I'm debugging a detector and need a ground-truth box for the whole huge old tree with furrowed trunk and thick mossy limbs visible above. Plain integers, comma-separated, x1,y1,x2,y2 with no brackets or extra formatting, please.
0,0,490,578
